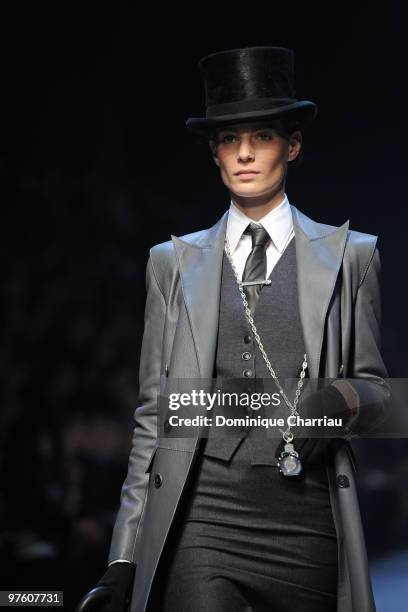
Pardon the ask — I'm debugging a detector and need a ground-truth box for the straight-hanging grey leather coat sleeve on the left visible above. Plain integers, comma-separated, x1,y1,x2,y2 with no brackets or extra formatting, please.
108,255,166,564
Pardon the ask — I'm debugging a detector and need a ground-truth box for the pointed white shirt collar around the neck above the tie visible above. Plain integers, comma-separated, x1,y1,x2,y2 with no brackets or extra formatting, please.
226,193,293,253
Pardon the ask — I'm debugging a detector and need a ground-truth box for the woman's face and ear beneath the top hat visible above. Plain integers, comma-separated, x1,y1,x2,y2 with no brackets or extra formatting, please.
212,120,302,198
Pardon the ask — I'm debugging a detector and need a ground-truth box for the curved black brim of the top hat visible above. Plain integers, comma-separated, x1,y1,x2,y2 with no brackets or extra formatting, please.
186,100,317,137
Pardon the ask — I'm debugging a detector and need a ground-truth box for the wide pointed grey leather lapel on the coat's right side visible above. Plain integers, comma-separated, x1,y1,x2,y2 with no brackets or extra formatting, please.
291,206,349,378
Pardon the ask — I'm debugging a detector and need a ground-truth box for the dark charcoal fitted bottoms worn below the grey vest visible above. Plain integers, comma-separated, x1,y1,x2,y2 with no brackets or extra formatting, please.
148,443,337,612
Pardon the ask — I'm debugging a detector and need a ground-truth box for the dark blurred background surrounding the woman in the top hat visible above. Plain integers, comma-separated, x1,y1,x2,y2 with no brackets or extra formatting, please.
4,0,408,612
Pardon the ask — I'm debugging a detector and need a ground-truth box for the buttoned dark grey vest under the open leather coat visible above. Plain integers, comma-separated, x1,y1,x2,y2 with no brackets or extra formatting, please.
203,238,305,465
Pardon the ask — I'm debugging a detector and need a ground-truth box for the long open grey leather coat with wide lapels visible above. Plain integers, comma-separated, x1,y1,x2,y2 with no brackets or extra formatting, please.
109,206,388,612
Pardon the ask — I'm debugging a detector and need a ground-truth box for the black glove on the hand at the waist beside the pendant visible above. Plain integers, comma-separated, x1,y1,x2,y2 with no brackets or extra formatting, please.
276,385,352,465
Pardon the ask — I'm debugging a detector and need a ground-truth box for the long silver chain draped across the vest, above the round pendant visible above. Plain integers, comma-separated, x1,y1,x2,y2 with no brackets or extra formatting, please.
225,237,307,442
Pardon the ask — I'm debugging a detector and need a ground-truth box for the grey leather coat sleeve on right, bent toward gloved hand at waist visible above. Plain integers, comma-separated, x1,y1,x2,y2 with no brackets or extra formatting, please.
348,245,389,437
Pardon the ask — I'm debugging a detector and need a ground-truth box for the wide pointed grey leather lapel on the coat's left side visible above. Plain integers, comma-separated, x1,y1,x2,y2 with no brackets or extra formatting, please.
171,211,228,379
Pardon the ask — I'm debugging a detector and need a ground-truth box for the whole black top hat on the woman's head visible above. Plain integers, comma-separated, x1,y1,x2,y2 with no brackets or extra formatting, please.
186,47,317,136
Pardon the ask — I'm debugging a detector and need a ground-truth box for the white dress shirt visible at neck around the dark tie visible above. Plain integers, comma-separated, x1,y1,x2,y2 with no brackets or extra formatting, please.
226,193,295,280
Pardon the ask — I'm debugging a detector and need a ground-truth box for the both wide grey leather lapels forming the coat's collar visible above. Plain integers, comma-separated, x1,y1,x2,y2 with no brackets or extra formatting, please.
171,205,349,378
